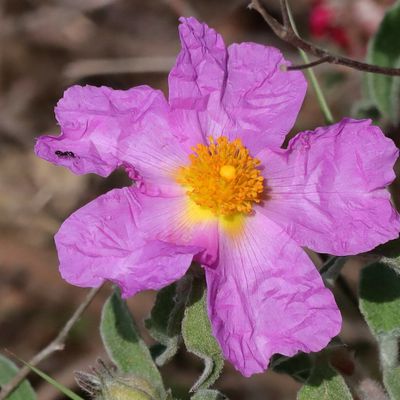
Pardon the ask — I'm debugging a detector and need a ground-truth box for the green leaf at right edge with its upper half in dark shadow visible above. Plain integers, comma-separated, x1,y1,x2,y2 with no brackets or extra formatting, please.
360,263,400,336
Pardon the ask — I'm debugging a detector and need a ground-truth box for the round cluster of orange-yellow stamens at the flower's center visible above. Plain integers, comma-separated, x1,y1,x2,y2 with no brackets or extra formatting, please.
178,136,264,215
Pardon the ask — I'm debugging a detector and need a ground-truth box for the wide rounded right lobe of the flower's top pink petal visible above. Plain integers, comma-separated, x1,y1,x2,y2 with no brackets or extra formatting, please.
222,43,307,154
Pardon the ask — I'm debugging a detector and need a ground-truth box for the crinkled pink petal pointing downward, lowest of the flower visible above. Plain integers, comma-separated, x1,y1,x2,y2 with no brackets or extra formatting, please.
206,211,341,376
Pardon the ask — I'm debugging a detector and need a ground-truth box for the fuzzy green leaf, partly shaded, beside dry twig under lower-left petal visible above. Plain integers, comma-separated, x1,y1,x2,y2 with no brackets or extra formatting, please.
100,290,166,398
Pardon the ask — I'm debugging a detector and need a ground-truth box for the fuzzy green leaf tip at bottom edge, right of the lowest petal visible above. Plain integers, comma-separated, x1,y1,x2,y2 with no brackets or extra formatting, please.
297,363,353,400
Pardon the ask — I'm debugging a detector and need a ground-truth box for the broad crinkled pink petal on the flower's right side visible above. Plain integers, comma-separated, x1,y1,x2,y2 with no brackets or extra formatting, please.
257,119,400,255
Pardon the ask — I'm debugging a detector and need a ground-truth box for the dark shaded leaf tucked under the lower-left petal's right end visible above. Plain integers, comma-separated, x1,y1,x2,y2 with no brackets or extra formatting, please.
145,276,192,366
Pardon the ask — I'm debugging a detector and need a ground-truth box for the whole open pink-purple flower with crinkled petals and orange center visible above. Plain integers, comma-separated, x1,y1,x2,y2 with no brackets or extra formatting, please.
36,18,400,376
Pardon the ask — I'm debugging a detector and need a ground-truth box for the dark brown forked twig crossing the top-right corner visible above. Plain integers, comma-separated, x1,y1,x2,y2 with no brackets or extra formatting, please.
249,0,400,76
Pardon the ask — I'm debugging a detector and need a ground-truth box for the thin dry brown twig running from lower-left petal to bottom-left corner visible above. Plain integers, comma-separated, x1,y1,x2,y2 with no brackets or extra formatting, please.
0,286,102,400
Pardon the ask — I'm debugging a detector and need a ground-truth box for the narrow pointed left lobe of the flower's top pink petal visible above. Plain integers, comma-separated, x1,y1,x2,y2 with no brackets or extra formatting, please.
168,17,227,146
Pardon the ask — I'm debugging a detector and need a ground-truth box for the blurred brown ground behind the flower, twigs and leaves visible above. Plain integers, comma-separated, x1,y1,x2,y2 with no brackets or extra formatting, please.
0,0,392,400
